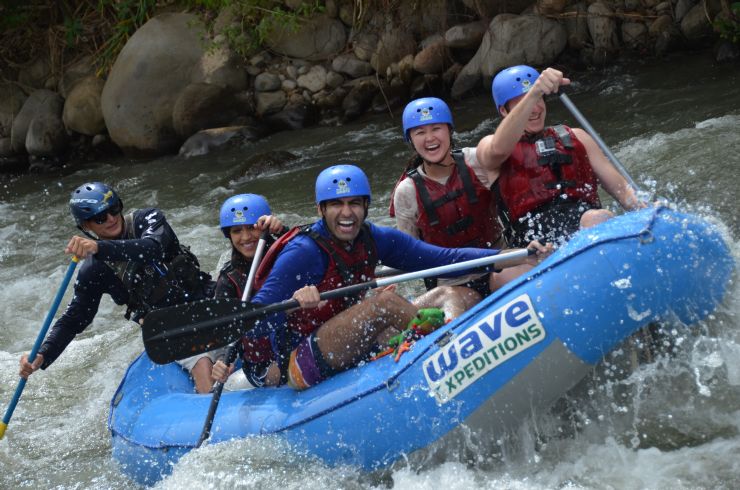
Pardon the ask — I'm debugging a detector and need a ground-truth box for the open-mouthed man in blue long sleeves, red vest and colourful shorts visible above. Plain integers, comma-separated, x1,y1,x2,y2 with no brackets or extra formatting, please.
214,165,552,389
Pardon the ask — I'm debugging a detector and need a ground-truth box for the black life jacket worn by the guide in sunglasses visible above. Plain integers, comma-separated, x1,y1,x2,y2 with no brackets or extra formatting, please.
105,213,204,320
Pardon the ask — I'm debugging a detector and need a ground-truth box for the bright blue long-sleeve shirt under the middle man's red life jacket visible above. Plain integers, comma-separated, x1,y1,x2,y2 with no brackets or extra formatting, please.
247,220,498,339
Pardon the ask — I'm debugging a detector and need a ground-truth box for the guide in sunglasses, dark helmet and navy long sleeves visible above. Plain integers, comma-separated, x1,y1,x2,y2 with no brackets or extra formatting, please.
20,182,213,379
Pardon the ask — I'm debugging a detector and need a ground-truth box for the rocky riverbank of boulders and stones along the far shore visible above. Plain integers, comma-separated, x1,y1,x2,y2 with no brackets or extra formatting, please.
0,0,738,173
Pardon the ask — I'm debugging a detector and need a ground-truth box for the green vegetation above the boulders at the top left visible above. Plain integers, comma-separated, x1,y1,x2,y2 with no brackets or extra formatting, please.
0,0,399,75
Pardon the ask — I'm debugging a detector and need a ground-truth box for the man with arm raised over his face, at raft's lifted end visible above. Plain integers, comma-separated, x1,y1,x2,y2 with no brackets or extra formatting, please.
477,65,643,246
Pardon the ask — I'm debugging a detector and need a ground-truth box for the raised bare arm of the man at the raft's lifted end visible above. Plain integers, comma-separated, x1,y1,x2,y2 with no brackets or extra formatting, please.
477,68,570,175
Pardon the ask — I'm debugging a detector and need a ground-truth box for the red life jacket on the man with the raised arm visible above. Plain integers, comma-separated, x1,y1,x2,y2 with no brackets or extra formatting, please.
493,125,601,225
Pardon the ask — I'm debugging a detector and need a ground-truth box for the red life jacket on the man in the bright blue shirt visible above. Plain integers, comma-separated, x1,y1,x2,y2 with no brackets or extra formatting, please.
255,224,378,335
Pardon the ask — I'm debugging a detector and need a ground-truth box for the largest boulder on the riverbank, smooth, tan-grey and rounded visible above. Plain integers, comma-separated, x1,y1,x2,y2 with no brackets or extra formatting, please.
101,13,204,155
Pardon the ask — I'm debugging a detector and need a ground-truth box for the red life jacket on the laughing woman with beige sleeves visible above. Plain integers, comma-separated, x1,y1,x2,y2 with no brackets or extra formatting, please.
389,151,501,248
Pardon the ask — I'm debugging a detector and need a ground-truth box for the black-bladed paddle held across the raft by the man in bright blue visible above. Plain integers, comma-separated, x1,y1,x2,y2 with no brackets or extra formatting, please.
142,249,536,364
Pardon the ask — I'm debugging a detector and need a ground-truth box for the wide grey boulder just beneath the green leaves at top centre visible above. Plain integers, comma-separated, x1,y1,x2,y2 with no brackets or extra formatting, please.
265,15,347,61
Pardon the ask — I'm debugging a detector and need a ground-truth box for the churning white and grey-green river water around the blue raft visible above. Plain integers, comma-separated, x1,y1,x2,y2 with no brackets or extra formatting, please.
0,54,740,490
